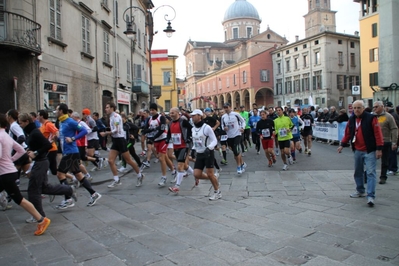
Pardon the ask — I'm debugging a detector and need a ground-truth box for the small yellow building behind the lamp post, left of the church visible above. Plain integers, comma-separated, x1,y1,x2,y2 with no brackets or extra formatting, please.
152,55,179,112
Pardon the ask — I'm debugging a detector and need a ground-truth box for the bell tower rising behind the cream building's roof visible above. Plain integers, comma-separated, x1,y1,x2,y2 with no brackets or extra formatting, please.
304,0,337,38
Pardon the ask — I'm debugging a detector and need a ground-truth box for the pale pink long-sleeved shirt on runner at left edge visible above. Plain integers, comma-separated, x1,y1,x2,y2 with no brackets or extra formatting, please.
0,128,25,175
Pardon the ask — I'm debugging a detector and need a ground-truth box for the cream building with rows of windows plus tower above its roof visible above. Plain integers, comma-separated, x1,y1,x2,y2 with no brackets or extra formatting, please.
272,0,360,108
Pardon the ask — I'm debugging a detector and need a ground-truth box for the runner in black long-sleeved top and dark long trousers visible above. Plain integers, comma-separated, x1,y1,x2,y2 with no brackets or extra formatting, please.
18,113,77,223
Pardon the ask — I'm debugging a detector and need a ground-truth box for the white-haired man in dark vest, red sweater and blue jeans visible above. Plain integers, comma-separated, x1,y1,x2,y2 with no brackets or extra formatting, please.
337,100,384,207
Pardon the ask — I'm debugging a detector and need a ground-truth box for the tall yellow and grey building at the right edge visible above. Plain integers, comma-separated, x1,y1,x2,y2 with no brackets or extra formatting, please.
354,0,399,106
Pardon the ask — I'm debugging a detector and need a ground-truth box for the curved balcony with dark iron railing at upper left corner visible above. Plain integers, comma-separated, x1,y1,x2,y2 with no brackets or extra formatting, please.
0,11,42,54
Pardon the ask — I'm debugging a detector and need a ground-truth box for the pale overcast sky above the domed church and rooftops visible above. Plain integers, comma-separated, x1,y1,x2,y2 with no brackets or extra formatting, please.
152,0,360,78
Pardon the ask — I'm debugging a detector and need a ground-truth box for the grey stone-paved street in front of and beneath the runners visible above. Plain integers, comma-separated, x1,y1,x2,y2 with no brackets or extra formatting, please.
0,142,399,266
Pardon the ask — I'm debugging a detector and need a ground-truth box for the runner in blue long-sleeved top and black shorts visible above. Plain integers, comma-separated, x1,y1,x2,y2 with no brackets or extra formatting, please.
55,103,101,210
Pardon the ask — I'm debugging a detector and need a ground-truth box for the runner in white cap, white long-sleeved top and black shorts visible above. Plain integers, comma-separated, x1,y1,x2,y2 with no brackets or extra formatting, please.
190,109,222,200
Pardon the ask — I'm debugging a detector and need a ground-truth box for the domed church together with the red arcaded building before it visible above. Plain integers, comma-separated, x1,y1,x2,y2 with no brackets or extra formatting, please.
184,0,288,109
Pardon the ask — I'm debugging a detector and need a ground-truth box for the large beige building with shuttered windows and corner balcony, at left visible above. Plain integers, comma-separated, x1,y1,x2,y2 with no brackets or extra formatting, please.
0,0,153,116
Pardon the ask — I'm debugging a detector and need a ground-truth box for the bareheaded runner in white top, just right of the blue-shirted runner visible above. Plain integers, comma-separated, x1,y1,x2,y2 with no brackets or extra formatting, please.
100,102,144,188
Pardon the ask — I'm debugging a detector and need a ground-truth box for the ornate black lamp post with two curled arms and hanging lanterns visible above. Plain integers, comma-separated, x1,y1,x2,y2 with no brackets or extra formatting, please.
123,0,176,103
